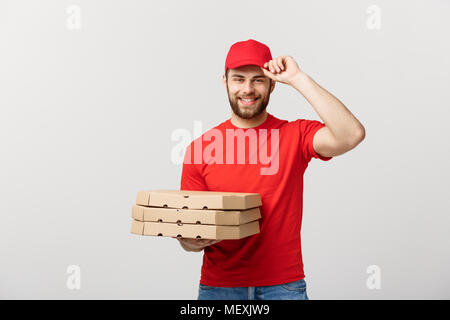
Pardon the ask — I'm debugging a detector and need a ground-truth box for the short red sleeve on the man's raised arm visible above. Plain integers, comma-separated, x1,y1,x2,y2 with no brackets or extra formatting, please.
297,119,333,163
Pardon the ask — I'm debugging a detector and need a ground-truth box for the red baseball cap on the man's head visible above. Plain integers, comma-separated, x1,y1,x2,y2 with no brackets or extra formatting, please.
225,39,272,72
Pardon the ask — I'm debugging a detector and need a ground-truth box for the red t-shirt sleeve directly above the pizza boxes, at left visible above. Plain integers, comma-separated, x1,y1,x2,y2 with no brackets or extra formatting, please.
180,143,208,191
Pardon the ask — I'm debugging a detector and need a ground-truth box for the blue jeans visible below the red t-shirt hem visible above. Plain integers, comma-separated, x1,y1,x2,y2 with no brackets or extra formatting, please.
198,279,309,300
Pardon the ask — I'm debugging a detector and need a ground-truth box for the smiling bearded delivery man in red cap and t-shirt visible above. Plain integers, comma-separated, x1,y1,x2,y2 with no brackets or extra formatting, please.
174,39,365,300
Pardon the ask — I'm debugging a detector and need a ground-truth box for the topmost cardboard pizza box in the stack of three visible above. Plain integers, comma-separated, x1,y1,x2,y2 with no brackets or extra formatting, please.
136,190,262,210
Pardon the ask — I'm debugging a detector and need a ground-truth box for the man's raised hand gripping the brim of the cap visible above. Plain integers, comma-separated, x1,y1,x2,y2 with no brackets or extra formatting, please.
260,56,302,85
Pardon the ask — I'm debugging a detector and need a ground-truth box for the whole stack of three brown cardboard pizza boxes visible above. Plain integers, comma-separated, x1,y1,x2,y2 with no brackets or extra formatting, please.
131,190,262,240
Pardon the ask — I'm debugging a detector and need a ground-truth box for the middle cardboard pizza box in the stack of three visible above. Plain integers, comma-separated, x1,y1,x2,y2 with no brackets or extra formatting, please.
131,205,261,225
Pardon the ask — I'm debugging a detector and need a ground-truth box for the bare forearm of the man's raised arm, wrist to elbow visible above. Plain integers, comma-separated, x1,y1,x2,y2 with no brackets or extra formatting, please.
292,72,365,141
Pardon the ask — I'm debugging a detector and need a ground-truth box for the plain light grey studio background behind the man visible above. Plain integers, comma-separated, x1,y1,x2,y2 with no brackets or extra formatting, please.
0,0,450,299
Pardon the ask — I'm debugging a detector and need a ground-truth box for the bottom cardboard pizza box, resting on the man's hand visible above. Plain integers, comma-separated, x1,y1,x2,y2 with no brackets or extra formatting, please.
131,220,260,240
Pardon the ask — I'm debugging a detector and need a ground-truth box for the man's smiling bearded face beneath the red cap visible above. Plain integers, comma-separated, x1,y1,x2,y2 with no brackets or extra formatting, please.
223,65,275,119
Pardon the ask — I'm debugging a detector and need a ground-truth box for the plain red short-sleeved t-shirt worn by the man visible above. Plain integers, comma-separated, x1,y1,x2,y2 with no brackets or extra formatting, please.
180,114,332,287
